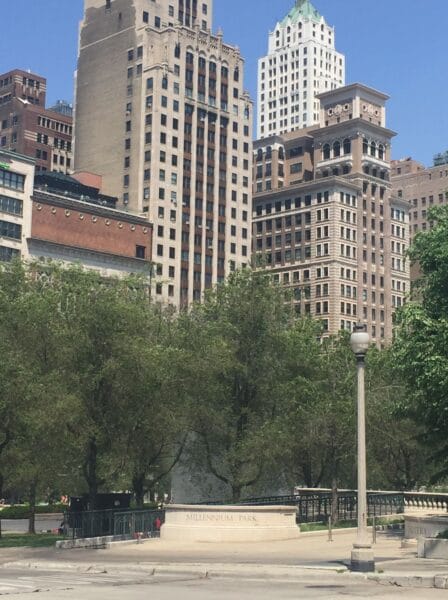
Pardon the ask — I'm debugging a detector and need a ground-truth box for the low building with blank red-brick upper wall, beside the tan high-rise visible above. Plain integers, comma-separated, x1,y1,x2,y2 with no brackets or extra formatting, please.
27,173,152,281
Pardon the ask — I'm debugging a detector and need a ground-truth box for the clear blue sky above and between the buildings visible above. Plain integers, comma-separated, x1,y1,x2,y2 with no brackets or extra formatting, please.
0,0,448,164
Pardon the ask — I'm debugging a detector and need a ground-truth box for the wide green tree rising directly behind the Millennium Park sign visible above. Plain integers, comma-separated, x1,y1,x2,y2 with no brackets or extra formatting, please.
182,269,291,501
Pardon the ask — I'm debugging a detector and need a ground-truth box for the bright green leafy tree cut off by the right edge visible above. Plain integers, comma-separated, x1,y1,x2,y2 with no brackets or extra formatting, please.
394,206,448,478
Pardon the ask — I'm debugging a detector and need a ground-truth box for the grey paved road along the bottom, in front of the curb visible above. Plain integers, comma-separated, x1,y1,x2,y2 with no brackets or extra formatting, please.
0,570,447,600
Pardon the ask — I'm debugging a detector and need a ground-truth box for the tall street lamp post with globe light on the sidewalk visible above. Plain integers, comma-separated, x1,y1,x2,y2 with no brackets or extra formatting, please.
350,324,375,573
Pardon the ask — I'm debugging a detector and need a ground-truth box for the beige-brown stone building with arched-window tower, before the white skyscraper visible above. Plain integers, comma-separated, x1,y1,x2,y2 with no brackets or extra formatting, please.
253,84,409,345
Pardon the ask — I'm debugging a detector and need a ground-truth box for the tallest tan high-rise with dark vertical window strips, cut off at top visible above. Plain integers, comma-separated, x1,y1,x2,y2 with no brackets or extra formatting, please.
75,0,252,306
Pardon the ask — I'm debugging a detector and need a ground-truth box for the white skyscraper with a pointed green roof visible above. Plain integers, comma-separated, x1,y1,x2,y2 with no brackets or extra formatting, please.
257,0,345,139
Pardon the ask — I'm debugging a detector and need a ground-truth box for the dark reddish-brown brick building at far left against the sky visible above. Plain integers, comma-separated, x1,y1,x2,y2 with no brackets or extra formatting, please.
0,69,73,173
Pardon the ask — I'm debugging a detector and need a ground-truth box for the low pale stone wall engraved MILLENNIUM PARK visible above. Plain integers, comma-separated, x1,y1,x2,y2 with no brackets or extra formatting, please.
160,504,300,542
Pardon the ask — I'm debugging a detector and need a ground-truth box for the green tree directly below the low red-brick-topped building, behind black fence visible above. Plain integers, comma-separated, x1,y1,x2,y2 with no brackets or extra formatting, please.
56,267,156,508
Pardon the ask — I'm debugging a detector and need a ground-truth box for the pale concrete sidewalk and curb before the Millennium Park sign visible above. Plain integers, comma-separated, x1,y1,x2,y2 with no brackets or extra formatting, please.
0,530,448,589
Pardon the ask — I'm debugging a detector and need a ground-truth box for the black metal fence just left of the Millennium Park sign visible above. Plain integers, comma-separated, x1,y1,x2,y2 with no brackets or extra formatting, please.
63,510,165,539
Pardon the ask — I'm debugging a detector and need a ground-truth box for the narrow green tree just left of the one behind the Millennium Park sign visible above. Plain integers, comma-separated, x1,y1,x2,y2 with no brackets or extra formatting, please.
121,305,187,507
